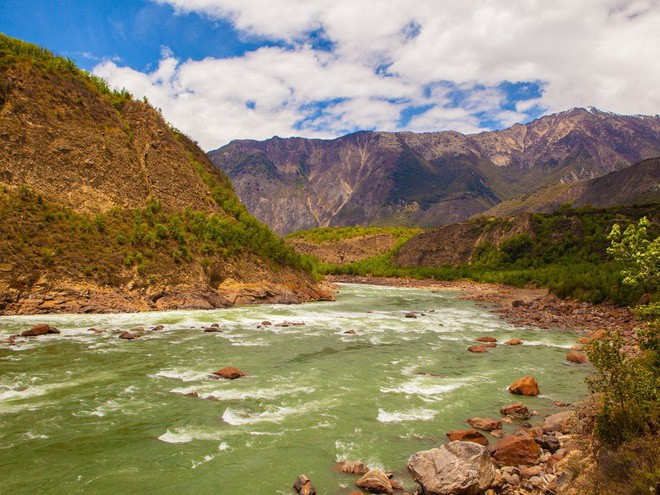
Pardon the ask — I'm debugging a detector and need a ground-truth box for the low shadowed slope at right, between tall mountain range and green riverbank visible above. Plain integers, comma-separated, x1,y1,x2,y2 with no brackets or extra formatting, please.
484,158,660,217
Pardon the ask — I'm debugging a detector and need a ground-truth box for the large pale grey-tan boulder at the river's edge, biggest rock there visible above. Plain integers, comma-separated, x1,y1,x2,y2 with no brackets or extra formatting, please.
408,442,495,495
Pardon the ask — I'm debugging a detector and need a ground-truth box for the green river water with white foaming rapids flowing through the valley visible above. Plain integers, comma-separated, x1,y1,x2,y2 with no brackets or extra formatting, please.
0,284,588,495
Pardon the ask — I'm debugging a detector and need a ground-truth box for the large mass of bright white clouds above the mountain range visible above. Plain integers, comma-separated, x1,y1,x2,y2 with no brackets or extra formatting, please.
95,0,660,149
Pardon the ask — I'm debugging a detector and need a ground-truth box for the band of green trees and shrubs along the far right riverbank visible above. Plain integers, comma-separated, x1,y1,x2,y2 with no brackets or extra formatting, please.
310,205,660,304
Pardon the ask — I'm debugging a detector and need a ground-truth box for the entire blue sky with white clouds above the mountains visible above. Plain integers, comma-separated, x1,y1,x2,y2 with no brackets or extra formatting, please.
0,0,660,150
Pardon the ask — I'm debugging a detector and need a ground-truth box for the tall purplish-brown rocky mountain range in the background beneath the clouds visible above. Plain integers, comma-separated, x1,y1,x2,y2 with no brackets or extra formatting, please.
209,108,660,233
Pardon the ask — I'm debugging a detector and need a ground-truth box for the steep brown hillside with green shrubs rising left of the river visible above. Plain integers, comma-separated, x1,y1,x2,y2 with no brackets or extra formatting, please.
0,35,327,313
